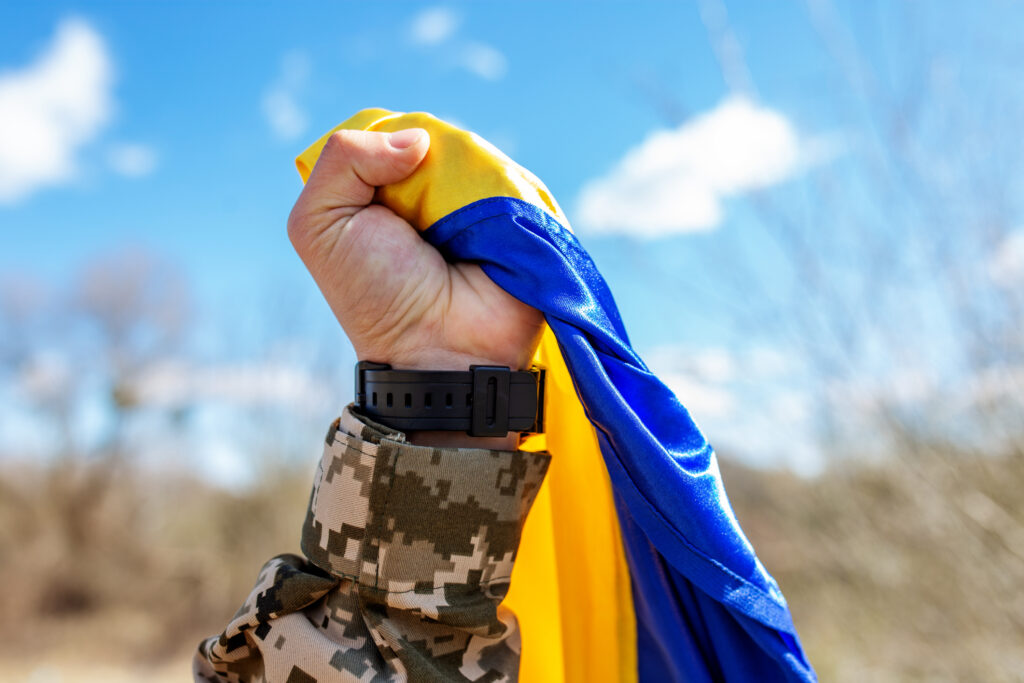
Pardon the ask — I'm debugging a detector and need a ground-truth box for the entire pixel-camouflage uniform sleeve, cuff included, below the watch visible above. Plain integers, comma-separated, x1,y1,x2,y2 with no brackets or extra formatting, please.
194,405,550,683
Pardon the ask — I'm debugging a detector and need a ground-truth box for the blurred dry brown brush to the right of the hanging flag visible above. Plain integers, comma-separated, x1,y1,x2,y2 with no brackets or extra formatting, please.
723,450,1024,681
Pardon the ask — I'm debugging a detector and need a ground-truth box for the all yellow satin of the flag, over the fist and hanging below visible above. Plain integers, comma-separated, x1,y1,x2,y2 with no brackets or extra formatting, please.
296,110,637,683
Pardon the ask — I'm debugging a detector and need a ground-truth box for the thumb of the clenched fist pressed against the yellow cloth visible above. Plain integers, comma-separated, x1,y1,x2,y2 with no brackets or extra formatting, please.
300,128,430,212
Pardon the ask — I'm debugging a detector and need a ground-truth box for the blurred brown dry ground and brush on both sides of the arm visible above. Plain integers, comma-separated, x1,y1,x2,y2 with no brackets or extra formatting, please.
0,440,1024,682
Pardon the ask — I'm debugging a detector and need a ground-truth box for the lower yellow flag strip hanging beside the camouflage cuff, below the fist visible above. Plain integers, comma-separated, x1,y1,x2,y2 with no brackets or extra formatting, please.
516,329,637,683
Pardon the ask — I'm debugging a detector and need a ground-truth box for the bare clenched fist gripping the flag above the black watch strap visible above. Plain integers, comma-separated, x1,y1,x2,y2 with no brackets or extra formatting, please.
288,128,544,442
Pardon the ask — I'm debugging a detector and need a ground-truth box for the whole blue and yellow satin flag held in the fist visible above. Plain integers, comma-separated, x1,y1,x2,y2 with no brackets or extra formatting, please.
297,110,816,682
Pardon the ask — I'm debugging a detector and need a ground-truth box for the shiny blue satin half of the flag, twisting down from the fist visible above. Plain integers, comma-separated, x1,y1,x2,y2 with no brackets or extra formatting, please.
424,197,816,681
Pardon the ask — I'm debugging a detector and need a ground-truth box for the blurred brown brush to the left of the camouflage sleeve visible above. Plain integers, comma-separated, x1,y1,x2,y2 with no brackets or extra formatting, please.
0,462,312,667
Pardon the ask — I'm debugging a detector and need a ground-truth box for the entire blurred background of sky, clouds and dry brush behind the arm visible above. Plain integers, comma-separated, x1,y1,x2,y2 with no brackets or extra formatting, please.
0,0,1024,682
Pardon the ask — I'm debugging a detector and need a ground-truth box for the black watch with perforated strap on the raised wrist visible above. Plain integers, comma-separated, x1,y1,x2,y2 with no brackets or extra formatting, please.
355,360,544,436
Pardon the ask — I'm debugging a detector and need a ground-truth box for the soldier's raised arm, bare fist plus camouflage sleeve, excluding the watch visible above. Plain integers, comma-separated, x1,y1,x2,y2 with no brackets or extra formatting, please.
194,128,549,683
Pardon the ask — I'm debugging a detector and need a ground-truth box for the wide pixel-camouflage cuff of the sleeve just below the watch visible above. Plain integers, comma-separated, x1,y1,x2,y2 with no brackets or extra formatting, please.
302,405,550,618
